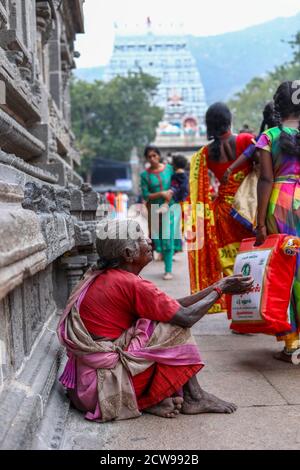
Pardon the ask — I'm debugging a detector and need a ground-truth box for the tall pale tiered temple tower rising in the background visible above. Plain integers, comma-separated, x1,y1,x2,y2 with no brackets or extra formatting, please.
104,18,207,156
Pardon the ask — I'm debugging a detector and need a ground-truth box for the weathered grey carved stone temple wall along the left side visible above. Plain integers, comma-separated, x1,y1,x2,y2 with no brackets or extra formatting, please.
0,0,98,449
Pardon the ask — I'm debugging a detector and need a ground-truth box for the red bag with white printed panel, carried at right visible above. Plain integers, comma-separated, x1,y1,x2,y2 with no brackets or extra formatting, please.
228,235,299,335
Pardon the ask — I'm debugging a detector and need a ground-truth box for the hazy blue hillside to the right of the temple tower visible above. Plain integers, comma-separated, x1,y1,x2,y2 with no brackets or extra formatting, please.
189,12,300,105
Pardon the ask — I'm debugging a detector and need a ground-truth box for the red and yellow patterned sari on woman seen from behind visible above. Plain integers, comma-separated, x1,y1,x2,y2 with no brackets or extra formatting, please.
188,134,253,313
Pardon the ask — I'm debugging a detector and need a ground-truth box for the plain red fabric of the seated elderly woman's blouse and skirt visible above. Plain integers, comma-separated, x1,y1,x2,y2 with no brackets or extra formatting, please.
79,269,203,410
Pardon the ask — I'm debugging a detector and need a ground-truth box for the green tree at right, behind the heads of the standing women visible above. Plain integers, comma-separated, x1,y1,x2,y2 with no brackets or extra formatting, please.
228,32,300,133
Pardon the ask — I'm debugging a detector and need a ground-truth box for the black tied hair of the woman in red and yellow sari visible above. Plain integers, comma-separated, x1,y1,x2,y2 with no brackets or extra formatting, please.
205,103,233,161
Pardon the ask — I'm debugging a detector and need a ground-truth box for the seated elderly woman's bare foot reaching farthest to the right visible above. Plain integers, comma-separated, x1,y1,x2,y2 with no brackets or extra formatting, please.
181,390,237,415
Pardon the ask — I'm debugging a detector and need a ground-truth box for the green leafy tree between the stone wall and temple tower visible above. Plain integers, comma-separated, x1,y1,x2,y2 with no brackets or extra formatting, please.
71,72,163,174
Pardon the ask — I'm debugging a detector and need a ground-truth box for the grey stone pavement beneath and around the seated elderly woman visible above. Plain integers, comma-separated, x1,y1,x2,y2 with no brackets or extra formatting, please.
61,254,300,450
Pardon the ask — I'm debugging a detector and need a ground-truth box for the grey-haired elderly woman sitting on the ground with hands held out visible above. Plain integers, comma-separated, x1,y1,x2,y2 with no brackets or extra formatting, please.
58,220,252,422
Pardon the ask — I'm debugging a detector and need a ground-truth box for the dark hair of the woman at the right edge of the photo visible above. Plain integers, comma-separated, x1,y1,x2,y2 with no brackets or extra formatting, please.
274,81,300,158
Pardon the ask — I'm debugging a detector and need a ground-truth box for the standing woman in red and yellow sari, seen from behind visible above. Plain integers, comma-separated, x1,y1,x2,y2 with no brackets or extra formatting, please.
186,103,253,312
